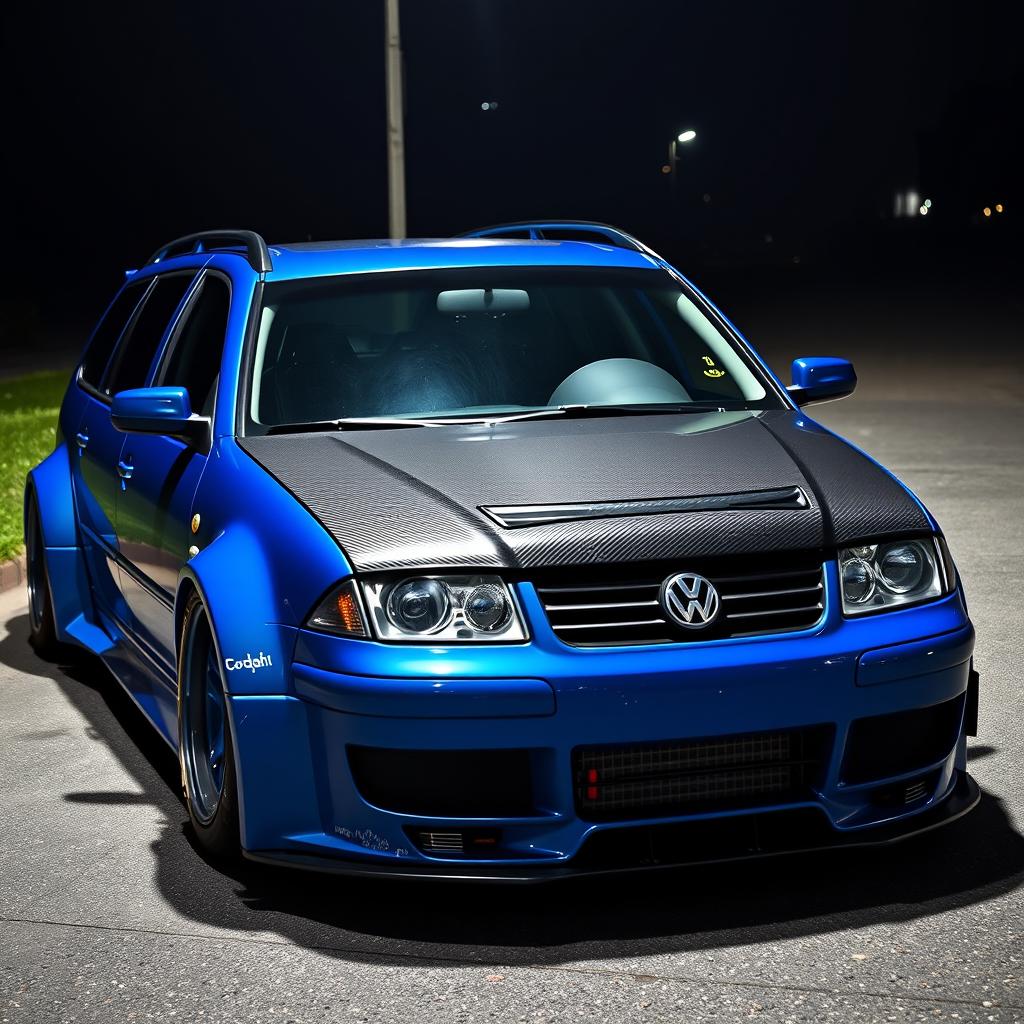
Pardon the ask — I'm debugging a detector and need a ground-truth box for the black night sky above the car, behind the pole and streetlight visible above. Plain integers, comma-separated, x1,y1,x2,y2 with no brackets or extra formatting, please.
2,0,1024,333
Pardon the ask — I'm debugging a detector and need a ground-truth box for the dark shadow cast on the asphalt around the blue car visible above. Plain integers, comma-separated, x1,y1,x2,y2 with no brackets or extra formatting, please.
0,616,1024,966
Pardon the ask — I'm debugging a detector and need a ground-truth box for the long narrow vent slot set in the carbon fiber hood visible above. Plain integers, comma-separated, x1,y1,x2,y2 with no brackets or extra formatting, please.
480,487,810,529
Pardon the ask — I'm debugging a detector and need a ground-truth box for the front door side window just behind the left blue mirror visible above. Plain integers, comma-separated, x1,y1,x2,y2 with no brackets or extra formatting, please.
156,274,230,416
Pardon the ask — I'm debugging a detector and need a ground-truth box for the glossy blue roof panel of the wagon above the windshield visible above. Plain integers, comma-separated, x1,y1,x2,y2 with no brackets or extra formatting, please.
254,239,658,282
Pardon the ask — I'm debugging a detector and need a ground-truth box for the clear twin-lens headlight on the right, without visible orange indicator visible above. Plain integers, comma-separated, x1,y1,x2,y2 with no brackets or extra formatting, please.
839,538,954,615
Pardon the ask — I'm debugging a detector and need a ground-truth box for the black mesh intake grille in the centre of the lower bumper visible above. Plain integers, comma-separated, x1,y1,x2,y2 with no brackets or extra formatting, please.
572,726,833,821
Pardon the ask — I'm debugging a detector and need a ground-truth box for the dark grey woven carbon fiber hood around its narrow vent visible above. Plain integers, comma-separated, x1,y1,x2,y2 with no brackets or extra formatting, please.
239,411,929,571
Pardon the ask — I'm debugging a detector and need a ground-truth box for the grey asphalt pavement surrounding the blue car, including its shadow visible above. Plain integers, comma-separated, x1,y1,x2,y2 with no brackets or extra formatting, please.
0,276,1024,1024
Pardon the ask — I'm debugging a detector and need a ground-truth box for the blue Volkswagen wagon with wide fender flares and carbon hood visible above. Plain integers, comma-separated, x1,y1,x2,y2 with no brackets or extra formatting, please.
25,222,978,881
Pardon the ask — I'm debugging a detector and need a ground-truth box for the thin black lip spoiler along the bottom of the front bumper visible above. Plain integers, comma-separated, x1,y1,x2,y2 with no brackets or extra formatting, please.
244,772,981,884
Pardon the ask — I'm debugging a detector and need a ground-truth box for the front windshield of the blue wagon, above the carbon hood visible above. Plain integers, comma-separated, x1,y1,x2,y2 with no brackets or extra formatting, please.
248,267,780,432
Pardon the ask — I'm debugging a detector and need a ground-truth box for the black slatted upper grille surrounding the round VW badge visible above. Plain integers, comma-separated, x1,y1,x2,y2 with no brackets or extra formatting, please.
536,553,824,647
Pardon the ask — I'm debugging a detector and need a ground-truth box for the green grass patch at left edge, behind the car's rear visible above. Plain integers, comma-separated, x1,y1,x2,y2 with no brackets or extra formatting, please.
0,370,69,562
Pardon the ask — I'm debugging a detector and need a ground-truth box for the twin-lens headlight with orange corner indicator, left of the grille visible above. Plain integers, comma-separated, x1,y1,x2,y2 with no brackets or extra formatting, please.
306,575,526,643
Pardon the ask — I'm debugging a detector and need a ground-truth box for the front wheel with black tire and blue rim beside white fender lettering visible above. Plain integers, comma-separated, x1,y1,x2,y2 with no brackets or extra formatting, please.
178,594,242,861
